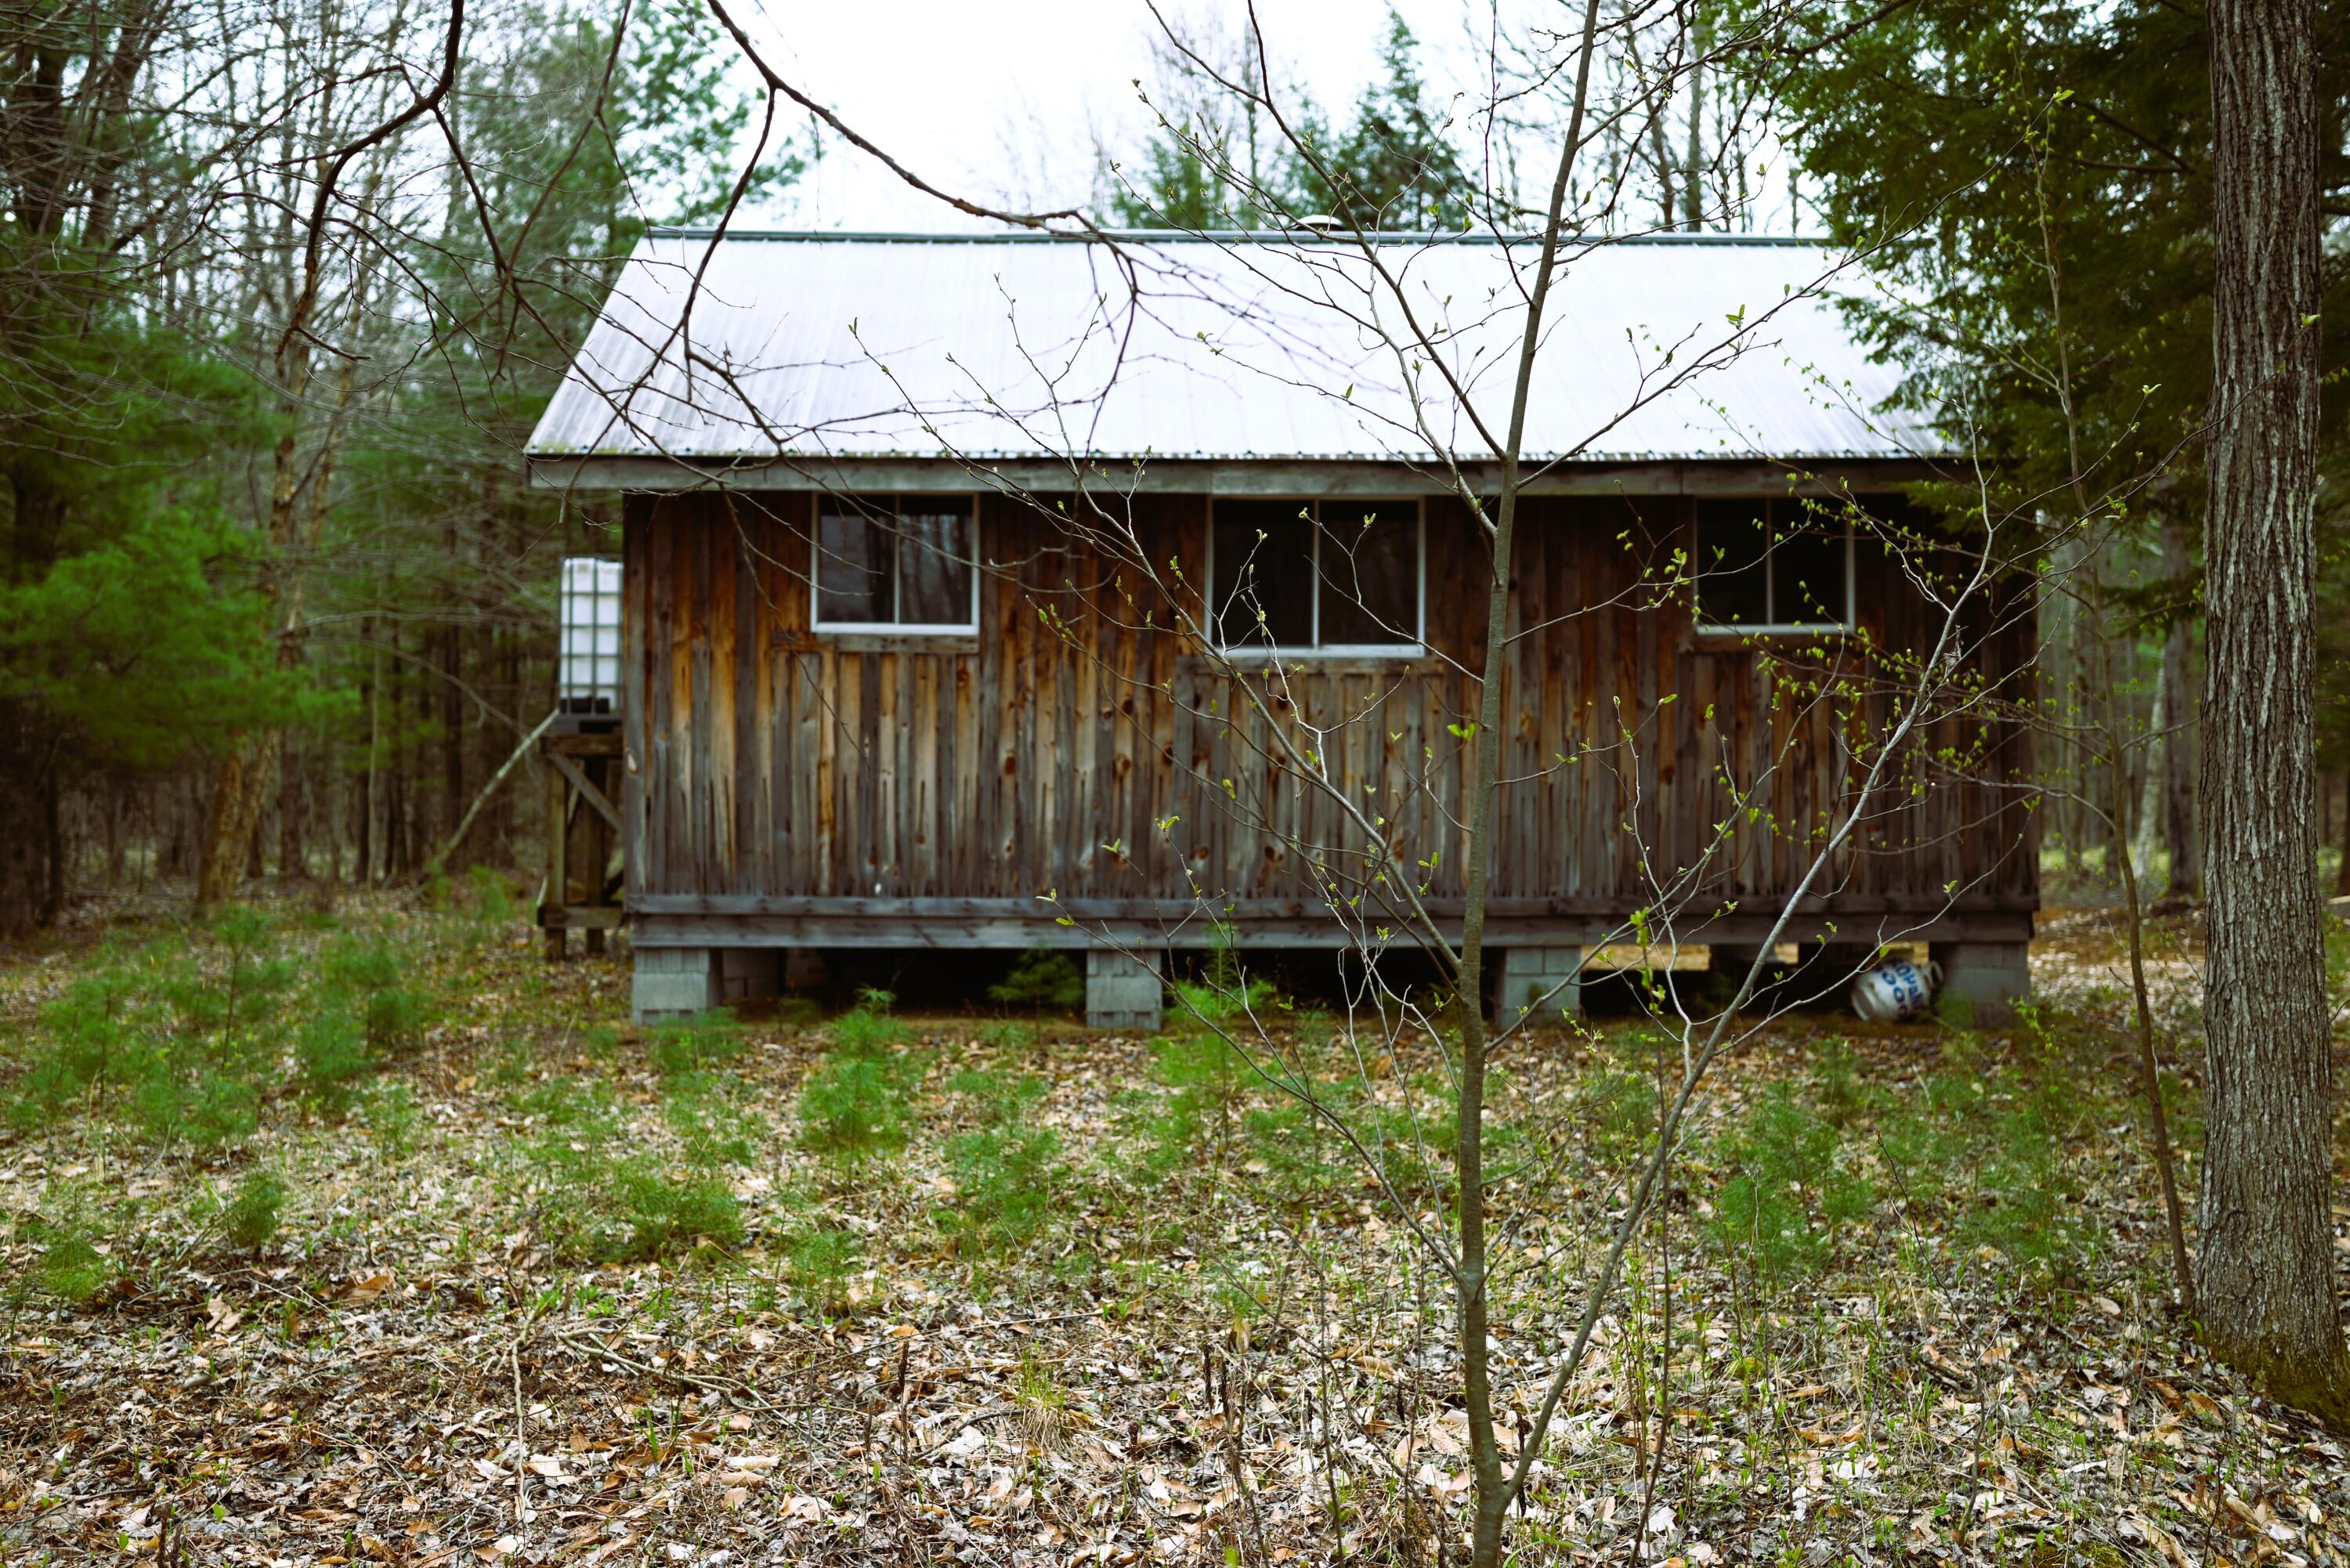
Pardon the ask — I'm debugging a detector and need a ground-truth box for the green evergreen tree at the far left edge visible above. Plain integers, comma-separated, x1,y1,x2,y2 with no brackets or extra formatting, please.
0,0,322,938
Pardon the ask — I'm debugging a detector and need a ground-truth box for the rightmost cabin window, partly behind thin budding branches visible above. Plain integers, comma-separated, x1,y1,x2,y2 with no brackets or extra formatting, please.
1694,496,1852,632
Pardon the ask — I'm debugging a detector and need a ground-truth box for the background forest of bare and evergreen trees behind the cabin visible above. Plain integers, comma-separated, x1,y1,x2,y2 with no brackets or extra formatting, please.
0,0,2350,938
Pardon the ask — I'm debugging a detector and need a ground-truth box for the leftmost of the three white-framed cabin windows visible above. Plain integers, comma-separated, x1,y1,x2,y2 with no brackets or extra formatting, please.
815,496,980,632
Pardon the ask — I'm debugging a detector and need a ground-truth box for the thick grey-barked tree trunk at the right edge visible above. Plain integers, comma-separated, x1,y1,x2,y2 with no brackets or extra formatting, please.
2197,0,2350,1425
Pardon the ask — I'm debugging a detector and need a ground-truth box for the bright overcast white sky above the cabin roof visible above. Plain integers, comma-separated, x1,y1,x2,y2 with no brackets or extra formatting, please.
738,0,1488,228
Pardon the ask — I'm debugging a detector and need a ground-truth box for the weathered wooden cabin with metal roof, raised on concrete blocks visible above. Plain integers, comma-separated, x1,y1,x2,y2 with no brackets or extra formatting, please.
529,233,2037,1028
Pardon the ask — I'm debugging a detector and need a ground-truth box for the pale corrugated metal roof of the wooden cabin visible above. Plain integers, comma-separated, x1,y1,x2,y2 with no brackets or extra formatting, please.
529,230,1932,463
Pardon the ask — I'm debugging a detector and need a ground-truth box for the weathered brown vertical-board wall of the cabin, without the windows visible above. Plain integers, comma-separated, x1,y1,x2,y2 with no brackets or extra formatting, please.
623,491,2037,968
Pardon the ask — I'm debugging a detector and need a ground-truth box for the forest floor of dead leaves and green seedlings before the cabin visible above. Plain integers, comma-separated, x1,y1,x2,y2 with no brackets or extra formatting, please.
0,884,2350,1568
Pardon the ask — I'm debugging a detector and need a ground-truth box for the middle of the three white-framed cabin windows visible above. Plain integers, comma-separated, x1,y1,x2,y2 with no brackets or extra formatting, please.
1208,500,1424,653
